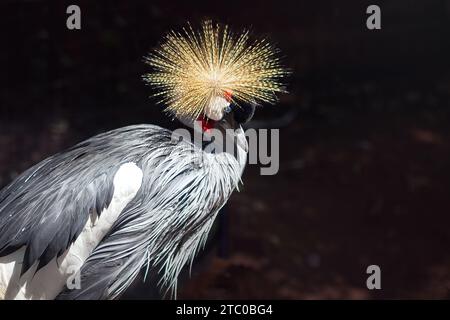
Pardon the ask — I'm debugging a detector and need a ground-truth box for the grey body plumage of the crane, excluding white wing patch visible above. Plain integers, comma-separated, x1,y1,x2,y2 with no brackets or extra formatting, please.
0,125,246,299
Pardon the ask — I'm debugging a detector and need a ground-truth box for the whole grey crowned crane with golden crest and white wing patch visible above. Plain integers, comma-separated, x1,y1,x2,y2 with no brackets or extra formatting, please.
0,20,289,300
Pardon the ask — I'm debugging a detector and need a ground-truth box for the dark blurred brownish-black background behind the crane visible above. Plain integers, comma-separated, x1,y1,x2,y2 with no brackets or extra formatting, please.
0,0,450,299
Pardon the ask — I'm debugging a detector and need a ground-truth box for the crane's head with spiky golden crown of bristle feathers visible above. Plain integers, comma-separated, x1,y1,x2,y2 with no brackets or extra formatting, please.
144,21,288,131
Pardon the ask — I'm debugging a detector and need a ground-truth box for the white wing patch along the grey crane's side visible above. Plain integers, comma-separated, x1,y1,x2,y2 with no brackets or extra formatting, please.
0,162,143,300
